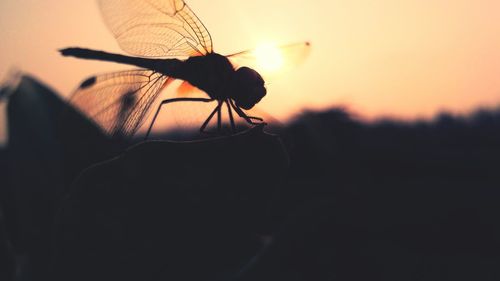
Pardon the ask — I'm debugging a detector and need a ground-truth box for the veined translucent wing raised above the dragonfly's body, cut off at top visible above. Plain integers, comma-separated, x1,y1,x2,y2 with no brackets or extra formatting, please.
98,0,212,57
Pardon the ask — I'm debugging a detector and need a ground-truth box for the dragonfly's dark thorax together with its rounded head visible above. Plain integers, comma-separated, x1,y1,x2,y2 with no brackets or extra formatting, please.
175,53,266,109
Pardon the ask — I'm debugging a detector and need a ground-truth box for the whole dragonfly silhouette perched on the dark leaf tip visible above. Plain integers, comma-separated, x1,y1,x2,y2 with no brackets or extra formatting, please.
60,0,309,138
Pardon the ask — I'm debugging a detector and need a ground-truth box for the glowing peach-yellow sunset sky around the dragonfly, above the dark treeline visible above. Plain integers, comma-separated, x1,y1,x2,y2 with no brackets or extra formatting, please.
0,0,500,122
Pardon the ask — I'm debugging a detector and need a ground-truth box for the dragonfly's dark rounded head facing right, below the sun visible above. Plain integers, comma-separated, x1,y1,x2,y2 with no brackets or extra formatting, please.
232,67,266,110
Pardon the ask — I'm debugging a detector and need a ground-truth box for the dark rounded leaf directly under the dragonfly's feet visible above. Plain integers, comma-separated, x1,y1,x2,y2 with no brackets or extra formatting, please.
55,125,287,280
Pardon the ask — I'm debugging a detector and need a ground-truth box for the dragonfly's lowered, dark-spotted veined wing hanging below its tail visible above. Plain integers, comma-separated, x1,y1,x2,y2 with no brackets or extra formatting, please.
71,70,169,137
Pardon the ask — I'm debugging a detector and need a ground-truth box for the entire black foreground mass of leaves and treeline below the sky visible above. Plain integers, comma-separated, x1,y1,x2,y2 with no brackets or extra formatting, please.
0,74,500,280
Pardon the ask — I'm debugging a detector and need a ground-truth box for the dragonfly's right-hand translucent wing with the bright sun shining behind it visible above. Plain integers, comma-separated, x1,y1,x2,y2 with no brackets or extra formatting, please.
227,42,311,83
